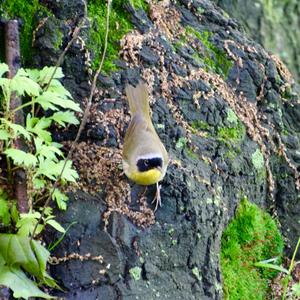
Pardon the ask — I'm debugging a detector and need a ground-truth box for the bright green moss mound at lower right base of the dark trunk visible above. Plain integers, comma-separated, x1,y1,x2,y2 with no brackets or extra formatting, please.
221,198,283,300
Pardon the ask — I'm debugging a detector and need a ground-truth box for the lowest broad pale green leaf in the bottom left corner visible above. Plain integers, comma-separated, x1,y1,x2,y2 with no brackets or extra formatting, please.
0,266,54,299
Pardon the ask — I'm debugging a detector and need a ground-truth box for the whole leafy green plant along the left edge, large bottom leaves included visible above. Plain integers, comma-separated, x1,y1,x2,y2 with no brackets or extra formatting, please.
0,63,81,299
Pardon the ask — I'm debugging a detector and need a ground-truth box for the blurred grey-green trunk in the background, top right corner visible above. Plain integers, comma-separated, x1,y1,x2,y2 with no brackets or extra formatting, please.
214,0,300,82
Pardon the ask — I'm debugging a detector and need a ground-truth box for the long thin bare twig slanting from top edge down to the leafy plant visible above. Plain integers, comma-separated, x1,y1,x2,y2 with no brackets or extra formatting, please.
31,0,111,239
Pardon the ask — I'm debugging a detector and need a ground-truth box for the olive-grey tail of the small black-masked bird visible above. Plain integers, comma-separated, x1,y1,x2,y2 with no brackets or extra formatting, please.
125,81,150,118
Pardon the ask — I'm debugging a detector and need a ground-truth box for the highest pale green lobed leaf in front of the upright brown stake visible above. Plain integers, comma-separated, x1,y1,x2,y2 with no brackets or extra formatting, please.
11,69,41,97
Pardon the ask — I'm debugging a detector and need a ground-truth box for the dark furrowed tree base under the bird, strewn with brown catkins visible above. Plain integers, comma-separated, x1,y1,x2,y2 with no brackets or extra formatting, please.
31,0,300,300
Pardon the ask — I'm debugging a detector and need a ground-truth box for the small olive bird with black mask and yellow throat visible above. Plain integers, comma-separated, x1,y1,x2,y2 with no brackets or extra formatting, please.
123,81,169,211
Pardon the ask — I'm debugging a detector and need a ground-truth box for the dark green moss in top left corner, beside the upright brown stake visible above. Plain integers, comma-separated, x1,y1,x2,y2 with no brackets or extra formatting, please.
0,0,50,64
